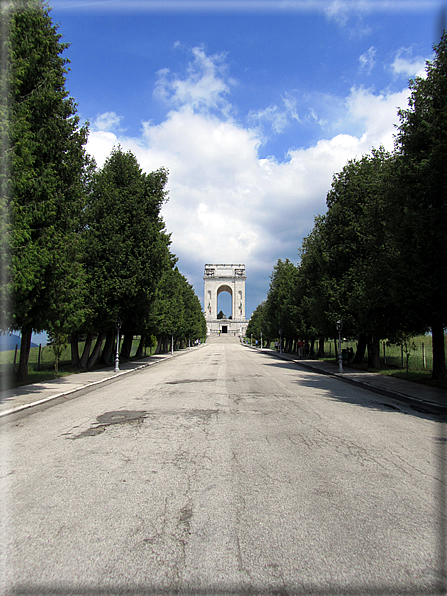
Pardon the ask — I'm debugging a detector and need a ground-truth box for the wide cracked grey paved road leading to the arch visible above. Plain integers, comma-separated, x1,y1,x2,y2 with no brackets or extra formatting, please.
1,340,443,596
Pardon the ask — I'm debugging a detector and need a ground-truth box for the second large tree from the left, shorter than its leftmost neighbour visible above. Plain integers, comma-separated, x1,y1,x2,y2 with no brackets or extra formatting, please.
83,147,174,340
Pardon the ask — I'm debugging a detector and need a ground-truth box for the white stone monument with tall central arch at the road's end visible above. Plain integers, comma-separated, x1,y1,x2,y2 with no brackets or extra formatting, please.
203,264,248,336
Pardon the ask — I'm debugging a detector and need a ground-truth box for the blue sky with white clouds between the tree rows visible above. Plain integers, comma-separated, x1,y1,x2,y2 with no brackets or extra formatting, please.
50,0,447,318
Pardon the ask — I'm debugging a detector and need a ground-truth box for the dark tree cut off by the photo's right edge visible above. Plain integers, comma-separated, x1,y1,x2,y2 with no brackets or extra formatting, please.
393,32,447,378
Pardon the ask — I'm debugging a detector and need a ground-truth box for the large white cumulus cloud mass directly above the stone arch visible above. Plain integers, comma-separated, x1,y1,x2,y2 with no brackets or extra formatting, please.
87,48,414,315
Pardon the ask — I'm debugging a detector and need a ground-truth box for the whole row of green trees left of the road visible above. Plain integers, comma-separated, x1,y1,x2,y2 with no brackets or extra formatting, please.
0,0,204,380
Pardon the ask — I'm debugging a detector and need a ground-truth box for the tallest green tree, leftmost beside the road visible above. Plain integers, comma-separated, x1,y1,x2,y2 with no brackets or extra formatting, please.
2,0,87,380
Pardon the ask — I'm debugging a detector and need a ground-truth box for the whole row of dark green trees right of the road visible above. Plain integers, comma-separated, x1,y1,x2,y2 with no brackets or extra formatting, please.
250,33,447,378
